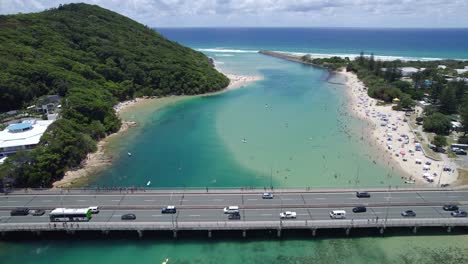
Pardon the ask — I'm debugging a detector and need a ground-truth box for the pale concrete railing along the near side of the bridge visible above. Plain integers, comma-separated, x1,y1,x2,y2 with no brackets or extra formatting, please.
0,218,468,232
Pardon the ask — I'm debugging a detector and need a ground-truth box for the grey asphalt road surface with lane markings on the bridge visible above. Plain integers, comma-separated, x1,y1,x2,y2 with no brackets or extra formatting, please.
0,191,468,223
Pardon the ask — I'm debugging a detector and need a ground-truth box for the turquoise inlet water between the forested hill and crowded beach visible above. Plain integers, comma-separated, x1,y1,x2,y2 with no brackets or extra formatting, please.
94,53,401,187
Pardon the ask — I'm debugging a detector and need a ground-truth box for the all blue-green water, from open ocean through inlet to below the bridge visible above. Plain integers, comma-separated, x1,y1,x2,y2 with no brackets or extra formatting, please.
0,28,468,264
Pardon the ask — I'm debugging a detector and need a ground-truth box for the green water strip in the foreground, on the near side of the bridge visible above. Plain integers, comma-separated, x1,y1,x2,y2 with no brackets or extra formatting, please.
0,235,468,264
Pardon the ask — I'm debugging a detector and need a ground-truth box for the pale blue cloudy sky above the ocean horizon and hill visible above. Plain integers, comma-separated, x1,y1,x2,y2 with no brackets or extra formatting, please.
0,0,468,28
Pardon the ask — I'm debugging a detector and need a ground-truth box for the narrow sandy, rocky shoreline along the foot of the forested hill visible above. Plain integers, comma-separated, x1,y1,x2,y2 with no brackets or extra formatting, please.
52,72,263,188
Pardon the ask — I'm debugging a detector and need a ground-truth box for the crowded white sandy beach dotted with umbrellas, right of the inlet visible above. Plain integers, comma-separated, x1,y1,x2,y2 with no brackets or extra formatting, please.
340,71,458,187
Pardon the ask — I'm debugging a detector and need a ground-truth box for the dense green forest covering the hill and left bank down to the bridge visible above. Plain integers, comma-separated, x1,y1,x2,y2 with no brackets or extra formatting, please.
0,4,229,187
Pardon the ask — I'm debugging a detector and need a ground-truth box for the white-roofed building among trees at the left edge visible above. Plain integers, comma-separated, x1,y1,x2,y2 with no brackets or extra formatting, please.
0,120,54,158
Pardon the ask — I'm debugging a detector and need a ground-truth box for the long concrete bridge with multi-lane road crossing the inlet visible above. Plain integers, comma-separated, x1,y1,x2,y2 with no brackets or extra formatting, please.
0,188,468,237
